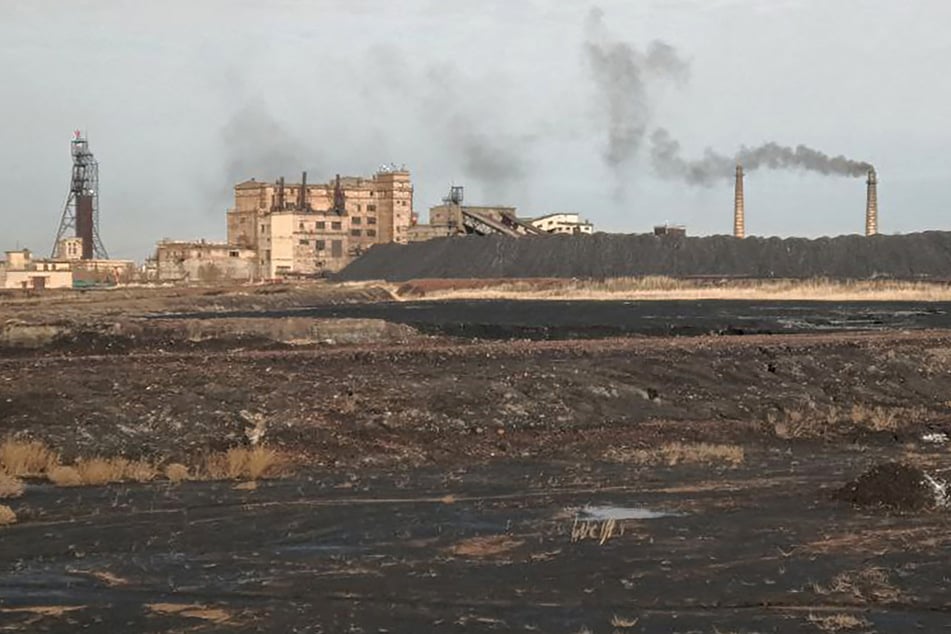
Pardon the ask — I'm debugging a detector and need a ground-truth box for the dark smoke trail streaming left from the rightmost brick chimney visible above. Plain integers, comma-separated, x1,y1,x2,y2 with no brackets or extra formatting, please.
651,129,872,185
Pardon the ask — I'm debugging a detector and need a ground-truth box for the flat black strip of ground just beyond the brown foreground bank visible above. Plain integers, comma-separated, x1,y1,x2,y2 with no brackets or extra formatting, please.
164,300,951,339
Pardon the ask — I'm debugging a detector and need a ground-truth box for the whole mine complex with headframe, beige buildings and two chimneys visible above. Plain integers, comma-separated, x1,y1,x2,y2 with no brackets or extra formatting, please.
0,131,878,289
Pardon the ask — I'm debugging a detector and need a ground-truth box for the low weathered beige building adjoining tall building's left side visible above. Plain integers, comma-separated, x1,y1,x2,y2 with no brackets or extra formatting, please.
156,240,259,284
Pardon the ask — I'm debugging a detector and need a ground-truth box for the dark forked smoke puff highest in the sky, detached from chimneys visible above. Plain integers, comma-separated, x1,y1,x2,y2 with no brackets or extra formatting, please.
585,7,689,168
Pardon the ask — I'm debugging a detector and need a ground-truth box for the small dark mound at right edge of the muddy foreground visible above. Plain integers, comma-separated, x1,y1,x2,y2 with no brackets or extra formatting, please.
838,462,948,511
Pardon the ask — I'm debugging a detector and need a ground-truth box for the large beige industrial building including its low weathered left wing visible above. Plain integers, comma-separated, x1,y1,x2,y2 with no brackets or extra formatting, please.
153,166,414,282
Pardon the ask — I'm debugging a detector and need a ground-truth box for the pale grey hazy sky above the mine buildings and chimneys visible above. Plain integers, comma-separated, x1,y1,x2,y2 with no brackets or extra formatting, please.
0,0,951,261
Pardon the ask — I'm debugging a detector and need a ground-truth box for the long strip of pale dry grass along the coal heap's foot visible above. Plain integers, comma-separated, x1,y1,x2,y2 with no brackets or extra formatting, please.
406,276,951,301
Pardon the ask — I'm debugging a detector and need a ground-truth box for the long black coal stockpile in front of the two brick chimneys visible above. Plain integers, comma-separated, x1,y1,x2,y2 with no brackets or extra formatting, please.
337,231,951,282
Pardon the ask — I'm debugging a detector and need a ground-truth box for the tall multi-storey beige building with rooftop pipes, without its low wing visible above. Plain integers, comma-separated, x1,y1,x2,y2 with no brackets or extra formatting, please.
228,169,414,278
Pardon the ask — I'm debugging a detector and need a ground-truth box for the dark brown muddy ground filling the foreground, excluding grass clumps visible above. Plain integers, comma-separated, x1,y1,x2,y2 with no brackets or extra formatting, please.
0,286,951,634
